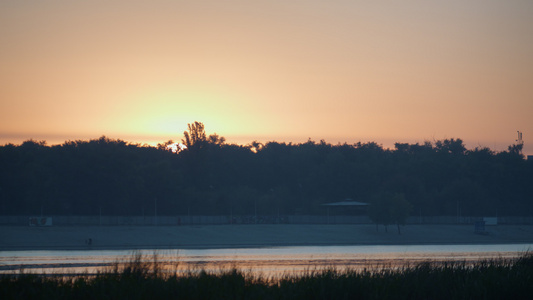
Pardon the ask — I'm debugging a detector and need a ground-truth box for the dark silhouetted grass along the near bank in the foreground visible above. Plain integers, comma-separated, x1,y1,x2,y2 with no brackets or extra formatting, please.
0,253,533,299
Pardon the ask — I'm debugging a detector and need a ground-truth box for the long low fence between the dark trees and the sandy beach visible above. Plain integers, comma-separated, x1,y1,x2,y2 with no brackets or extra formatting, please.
0,215,533,226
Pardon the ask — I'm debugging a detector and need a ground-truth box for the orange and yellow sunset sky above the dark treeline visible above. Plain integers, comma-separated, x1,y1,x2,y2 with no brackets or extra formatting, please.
0,0,533,155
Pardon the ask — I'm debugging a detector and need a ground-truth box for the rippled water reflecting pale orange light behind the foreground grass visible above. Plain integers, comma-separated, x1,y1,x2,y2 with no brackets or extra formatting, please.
0,244,533,276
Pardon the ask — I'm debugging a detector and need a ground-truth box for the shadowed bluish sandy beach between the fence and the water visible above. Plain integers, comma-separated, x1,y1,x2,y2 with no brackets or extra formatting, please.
0,224,533,251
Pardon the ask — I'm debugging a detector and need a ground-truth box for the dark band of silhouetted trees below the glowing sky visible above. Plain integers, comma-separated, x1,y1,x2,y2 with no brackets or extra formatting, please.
0,122,533,216
